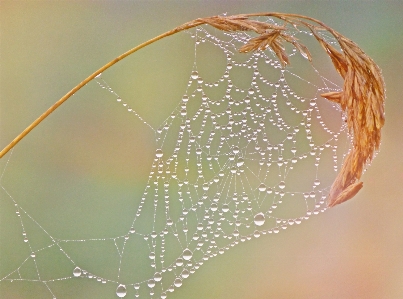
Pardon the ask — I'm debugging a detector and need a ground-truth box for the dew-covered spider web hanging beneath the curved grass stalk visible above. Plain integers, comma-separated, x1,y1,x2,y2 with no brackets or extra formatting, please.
0,18,352,298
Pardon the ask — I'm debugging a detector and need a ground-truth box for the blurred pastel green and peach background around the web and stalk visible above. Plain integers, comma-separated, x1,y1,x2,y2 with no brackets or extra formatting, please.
0,0,403,299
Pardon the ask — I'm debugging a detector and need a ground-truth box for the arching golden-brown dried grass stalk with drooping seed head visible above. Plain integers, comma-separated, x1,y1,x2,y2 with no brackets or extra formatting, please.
0,12,385,207
